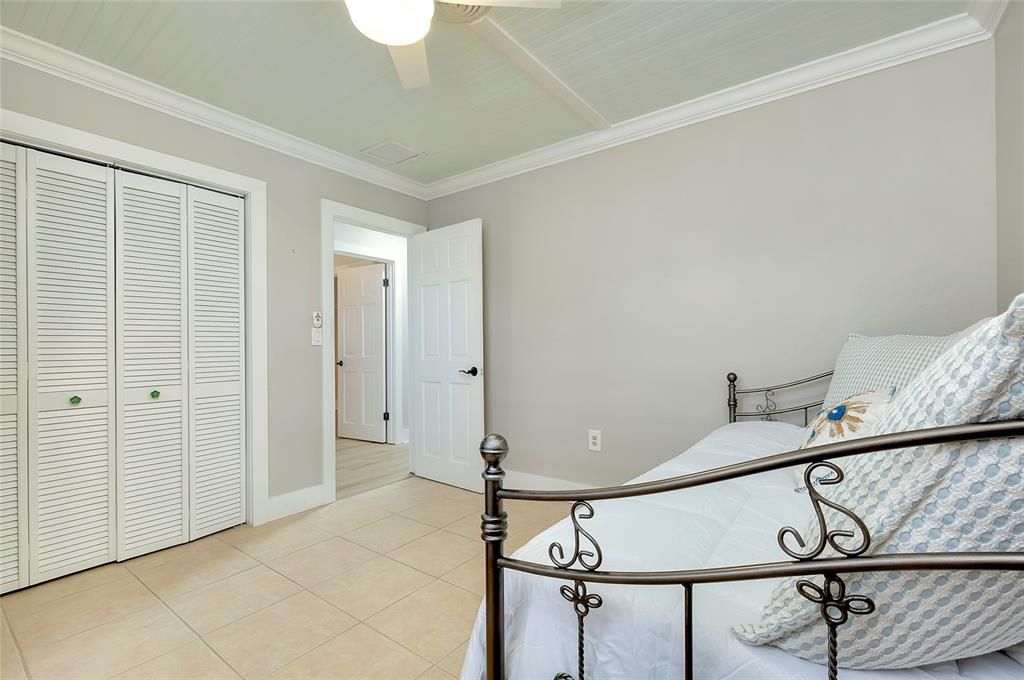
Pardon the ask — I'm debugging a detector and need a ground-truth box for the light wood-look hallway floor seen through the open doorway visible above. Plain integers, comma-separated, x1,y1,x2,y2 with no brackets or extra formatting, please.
334,437,411,500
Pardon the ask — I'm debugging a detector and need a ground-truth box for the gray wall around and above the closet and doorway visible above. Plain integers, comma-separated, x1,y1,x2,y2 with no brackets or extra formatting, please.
0,60,427,496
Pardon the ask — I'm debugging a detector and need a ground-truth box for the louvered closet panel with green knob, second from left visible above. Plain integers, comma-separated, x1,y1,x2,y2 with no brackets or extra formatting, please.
27,150,115,583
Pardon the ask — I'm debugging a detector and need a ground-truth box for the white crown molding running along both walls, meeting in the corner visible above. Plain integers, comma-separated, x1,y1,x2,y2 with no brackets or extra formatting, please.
0,11,991,201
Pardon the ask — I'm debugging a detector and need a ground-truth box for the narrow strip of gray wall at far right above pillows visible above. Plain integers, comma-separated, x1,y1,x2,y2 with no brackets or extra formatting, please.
995,2,1024,306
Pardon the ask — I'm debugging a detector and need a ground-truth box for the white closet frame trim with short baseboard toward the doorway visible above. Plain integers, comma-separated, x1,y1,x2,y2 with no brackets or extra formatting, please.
0,109,272,524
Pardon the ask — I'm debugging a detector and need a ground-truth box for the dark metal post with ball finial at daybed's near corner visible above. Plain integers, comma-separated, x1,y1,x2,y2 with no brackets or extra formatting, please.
480,434,509,680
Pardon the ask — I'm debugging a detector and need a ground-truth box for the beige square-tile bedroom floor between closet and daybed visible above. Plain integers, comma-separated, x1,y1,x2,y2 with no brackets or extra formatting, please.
0,477,567,680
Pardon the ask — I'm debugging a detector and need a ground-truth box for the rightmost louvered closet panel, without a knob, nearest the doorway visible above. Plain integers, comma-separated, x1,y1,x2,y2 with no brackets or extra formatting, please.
188,186,246,539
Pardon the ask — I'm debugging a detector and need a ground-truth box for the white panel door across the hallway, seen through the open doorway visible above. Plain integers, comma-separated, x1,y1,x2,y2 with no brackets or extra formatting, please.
337,264,387,442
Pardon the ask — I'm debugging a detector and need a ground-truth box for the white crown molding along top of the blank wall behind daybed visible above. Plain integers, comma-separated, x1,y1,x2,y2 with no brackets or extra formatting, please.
426,12,991,200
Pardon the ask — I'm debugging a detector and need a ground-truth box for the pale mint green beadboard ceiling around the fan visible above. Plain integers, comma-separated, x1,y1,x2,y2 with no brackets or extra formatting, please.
0,0,966,182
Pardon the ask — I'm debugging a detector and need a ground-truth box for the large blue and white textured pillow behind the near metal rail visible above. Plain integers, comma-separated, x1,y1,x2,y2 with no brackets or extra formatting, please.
734,295,1024,669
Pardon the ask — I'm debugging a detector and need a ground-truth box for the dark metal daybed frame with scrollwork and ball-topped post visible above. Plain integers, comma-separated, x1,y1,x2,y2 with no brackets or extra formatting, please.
480,373,1024,680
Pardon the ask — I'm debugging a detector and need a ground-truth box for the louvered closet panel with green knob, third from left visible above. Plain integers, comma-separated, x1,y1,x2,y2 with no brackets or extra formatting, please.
116,170,188,559
